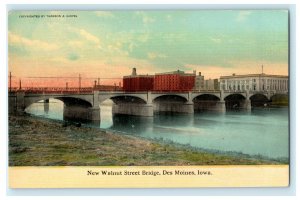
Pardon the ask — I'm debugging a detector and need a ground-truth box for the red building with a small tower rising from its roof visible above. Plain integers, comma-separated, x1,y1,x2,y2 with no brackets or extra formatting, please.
123,68,154,92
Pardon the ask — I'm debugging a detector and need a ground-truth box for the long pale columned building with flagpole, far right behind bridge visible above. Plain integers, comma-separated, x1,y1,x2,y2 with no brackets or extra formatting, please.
220,73,289,91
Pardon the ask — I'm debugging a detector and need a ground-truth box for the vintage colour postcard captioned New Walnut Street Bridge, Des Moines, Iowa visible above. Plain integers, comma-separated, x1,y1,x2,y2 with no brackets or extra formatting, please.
8,10,290,188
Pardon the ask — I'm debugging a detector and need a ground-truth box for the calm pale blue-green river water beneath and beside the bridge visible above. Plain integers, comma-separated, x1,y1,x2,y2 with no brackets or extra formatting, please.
26,99,289,159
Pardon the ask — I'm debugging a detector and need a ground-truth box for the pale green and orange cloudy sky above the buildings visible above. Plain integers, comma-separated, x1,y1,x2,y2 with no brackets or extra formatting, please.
8,10,288,84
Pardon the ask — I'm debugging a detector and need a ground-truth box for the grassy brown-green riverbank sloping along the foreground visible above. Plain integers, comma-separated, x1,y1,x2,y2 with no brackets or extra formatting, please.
9,115,282,166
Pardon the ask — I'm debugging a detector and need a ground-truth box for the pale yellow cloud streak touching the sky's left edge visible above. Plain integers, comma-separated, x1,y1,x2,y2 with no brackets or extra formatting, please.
8,32,59,51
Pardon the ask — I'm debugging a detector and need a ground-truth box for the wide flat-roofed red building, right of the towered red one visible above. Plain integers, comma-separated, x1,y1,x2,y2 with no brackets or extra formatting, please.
153,70,196,91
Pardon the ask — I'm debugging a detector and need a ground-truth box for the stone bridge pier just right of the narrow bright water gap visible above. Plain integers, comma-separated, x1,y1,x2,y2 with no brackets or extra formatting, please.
112,103,153,117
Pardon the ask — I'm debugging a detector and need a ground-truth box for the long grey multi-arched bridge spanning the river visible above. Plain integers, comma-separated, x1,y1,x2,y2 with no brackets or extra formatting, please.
9,90,288,121
